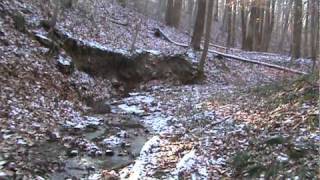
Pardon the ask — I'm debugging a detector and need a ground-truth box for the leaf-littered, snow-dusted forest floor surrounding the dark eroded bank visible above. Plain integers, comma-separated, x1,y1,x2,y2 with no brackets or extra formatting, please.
0,0,320,179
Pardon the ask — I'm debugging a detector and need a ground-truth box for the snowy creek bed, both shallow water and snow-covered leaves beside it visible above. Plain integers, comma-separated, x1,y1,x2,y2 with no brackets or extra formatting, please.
25,81,245,179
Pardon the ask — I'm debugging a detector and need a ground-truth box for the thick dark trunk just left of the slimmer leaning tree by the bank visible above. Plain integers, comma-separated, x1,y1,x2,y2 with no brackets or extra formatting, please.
191,0,206,50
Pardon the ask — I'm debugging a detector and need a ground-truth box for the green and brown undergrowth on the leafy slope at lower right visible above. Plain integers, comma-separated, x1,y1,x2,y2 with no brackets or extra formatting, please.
214,73,319,179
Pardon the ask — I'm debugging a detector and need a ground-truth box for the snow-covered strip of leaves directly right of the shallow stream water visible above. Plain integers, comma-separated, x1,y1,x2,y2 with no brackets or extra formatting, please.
118,85,245,179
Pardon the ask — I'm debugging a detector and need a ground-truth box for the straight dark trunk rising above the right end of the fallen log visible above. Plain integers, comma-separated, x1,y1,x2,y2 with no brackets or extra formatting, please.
291,0,302,59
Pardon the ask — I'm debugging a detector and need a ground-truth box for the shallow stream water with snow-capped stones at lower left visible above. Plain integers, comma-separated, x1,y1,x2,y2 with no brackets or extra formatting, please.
29,95,158,180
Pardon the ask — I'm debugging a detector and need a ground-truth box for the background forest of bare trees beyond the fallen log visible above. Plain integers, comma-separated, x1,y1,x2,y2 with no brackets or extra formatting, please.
127,0,320,64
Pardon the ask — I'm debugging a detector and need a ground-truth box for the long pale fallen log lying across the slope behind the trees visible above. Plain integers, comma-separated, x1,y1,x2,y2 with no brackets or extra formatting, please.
156,28,308,75
